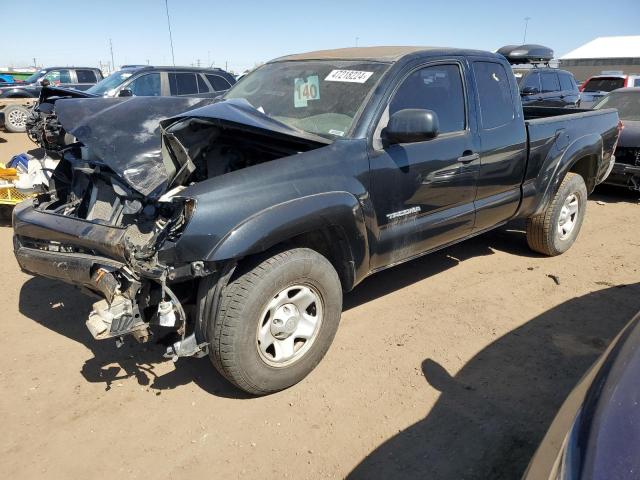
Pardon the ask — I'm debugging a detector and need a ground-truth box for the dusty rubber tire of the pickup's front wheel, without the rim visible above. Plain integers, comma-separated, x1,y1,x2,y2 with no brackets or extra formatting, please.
206,248,342,395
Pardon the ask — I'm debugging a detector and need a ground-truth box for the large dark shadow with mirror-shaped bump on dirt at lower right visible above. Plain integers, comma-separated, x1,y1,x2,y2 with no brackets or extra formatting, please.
349,283,640,480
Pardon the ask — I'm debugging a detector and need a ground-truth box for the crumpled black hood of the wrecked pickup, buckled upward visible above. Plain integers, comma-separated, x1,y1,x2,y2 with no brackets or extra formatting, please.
55,97,331,197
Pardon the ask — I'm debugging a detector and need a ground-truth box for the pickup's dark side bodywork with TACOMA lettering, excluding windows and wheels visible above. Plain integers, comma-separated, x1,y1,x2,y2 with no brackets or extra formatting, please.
14,49,618,290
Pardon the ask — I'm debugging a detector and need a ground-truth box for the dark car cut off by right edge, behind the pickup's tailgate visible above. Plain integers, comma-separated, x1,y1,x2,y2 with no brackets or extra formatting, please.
594,87,640,192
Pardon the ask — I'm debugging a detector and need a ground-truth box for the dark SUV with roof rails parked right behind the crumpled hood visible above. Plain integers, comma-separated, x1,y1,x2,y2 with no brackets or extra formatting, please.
87,66,236,97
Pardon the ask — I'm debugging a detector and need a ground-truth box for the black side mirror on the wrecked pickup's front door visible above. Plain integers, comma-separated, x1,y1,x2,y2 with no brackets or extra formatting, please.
381,108,439,145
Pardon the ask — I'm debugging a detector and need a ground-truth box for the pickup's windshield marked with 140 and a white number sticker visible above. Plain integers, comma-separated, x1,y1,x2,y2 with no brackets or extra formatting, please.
224,61,389,139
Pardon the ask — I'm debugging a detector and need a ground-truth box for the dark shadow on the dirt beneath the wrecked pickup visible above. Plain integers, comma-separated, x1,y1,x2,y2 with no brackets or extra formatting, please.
19,225,535,398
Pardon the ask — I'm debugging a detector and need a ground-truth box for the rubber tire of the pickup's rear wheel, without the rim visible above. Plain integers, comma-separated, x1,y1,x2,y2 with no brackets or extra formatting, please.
527,173,587,256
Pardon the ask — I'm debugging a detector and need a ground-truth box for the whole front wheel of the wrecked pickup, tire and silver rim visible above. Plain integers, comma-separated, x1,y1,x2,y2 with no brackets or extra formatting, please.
207,248,342,395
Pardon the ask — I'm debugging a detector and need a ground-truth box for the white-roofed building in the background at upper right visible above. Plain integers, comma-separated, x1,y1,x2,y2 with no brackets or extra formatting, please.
560,35,640,81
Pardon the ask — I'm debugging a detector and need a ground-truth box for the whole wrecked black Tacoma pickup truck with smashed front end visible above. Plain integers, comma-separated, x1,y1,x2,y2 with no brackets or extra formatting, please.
13,47,619,394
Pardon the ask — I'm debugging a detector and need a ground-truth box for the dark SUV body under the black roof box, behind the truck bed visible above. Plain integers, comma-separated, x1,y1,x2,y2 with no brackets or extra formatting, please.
513,67,581,107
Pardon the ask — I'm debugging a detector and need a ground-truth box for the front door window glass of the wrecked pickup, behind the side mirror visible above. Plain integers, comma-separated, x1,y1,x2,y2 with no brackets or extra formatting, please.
389,65,466,133
